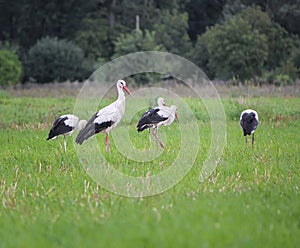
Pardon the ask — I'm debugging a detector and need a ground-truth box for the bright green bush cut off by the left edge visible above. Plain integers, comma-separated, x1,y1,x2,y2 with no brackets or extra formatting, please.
0,50,23,85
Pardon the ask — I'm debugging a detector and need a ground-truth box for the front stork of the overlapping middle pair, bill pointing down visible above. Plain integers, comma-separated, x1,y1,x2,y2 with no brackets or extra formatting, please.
137,105,179,148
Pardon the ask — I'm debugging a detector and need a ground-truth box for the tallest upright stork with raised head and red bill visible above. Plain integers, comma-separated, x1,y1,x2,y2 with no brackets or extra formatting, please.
76,80,131,152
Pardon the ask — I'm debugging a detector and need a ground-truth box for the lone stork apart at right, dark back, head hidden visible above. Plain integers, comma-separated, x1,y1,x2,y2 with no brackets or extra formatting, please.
240,109,258,148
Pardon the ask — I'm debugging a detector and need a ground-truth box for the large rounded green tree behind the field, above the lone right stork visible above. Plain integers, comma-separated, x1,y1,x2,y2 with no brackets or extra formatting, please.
203,17,268,80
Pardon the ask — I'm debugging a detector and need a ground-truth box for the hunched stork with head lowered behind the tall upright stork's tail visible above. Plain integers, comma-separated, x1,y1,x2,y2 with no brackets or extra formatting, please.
47,115,87,151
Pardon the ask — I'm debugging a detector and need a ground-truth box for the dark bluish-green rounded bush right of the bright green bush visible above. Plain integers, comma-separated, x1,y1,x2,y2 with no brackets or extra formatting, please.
25,37,87,83
